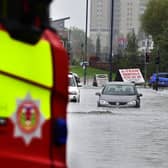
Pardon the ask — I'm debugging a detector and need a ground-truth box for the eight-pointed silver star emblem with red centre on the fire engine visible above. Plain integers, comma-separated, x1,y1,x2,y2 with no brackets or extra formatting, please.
11,93,45,145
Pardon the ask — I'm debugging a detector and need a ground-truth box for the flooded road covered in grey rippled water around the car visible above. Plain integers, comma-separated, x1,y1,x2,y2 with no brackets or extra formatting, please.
67,88,168,168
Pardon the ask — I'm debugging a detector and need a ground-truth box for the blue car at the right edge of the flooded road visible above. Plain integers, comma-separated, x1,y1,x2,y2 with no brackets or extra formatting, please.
149,72,168,87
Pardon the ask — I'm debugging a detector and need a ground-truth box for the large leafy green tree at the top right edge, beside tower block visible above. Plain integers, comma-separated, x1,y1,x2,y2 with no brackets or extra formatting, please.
142,0,168,71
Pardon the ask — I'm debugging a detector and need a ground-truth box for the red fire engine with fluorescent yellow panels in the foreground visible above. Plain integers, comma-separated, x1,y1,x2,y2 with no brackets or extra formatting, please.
0,0,68,168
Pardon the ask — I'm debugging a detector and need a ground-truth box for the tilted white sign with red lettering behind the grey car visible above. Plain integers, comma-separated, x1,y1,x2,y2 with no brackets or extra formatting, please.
119,68,145,84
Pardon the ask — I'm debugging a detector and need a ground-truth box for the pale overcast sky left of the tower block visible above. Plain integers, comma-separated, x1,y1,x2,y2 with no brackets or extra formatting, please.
50,0,86,30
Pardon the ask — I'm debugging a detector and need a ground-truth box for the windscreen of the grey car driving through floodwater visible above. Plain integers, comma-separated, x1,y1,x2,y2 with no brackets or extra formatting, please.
102,85,136,95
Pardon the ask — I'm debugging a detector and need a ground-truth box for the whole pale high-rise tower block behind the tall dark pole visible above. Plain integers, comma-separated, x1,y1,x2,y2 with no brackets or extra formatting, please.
90,0,149,52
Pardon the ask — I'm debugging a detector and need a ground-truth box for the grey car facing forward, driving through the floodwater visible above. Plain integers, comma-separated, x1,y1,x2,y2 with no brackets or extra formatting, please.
96,82,142,108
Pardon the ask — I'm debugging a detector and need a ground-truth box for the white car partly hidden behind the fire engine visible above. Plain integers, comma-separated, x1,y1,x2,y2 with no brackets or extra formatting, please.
68,73,80,102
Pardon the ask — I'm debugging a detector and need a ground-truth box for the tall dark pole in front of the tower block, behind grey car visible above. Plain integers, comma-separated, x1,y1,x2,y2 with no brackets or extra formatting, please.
109,0,114,81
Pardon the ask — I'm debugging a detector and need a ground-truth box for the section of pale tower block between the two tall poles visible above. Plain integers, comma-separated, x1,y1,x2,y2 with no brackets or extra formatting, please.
90,0,111,54
